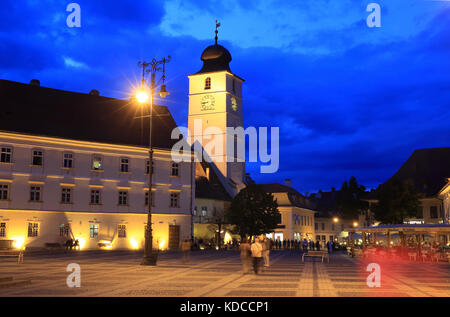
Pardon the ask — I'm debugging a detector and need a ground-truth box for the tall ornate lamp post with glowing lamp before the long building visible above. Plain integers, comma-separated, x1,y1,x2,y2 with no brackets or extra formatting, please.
136,56,170,265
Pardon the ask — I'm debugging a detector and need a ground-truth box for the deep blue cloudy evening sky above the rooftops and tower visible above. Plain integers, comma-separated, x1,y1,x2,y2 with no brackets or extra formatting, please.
0,0,450,192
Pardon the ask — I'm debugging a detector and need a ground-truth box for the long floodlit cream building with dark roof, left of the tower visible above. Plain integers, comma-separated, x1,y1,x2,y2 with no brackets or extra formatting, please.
0,80,195,249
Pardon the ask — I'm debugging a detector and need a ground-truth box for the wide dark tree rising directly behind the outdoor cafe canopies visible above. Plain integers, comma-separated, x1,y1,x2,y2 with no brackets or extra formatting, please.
374,179,420,224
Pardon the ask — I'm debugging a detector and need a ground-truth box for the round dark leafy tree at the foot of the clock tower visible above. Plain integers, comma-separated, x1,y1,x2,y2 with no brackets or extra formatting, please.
225,184,281,238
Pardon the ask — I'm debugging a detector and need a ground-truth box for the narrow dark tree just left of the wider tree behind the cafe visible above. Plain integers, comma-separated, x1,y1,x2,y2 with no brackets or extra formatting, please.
336,176,368,219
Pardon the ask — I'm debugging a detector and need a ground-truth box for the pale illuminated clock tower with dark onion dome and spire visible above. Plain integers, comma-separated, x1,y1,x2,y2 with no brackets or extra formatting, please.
188,30,245,187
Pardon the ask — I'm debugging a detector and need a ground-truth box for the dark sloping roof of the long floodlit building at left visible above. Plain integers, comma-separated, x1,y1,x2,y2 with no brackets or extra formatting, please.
0,80,177,149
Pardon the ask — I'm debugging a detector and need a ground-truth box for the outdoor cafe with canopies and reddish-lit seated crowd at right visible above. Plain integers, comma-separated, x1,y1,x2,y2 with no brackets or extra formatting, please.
347,224,450,262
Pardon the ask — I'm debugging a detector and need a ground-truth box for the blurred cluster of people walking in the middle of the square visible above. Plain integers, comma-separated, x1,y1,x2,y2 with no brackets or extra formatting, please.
239,235,272,274
